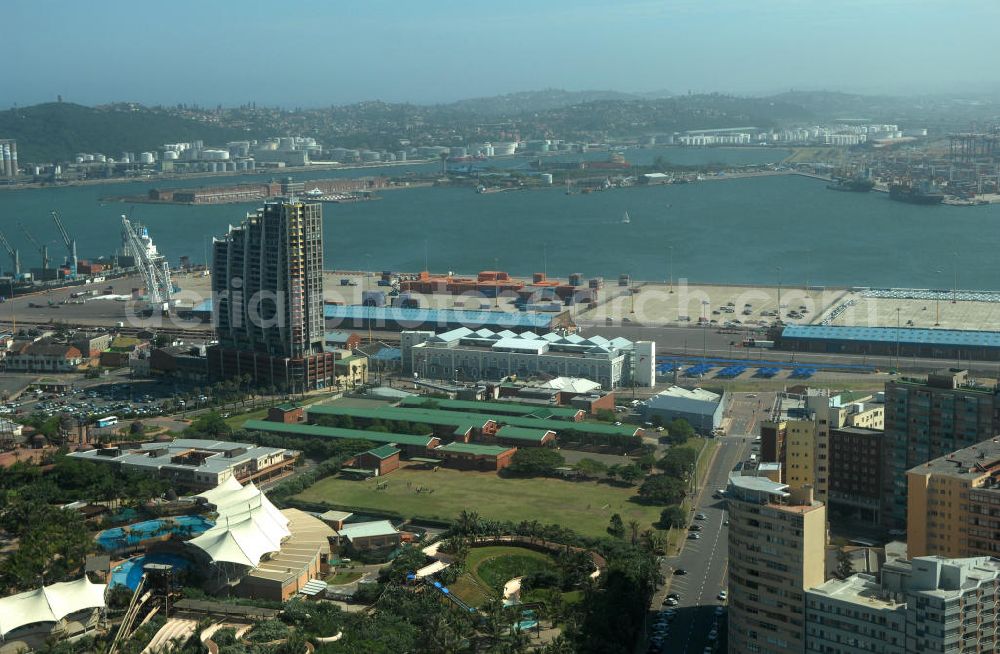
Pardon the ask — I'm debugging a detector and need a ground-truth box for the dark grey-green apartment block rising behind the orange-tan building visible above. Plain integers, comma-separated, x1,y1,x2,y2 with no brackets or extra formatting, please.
882,370,1000,529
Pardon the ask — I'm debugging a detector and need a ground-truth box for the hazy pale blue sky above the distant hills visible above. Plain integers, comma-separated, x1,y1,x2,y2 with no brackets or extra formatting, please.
7,0,1000,106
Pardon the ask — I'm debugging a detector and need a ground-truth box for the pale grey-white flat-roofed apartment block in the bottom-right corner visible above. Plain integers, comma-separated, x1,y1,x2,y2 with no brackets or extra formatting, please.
805,556,1000,654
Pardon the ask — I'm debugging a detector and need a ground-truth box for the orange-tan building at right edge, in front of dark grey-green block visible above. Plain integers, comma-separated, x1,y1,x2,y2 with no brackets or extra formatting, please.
906,438,1000,557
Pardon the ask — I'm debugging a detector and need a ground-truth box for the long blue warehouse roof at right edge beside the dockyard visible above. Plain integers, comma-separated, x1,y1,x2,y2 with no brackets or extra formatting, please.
781,325,1000,348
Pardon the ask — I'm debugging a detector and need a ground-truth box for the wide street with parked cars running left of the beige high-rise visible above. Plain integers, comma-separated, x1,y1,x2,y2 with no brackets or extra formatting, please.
653,393,760,654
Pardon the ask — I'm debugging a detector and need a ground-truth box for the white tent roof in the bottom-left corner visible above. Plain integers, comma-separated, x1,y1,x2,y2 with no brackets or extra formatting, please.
0,576,107,636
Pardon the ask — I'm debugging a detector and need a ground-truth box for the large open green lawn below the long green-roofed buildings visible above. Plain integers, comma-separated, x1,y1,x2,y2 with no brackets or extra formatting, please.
296,466,662,537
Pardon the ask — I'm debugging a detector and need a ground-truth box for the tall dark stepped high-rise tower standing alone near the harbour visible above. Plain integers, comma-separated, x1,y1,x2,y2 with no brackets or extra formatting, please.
208,198,336,392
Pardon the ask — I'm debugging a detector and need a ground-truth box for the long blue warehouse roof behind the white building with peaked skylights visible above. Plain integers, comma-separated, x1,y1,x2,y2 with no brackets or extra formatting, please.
323,305,552,330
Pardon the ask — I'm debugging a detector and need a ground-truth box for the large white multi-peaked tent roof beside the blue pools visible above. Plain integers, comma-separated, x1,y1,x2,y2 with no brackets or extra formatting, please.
188,477,291,568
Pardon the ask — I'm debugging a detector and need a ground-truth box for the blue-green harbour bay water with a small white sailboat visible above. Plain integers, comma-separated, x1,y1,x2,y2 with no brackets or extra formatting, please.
0,149,1000,289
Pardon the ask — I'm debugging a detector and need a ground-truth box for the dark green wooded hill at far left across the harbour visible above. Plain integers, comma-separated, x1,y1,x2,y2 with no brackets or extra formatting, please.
0,102,254,163
